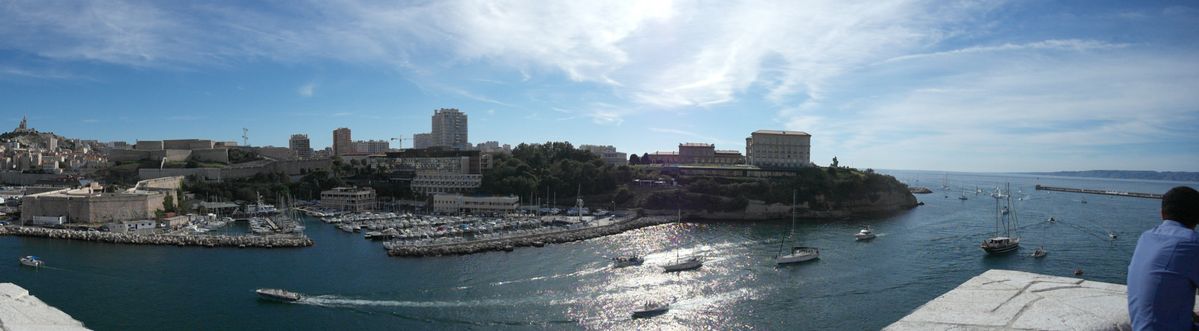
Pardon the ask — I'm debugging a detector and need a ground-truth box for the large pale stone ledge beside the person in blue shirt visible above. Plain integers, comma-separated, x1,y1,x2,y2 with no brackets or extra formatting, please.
884,270,1146,330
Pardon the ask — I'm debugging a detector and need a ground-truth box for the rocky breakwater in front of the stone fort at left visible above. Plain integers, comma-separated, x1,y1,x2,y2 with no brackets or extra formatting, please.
0,225,313,248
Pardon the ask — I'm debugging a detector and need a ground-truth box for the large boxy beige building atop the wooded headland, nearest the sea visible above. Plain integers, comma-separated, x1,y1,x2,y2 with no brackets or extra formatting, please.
746,130,812,169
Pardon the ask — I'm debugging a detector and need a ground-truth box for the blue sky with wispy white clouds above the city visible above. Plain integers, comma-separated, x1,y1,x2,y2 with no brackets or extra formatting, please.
0,0,1199,171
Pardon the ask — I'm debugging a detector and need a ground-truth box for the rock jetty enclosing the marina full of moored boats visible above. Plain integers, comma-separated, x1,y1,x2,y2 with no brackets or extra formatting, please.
387,216,677,257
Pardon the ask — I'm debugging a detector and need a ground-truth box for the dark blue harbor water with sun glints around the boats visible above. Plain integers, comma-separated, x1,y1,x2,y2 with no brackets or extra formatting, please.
0,171,1199,330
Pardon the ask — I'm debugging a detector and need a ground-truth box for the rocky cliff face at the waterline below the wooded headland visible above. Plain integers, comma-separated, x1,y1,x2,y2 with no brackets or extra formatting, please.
644,187,917,221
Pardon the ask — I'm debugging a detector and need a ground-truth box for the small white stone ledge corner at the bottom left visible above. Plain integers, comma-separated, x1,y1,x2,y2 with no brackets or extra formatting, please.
0,283,88,331
